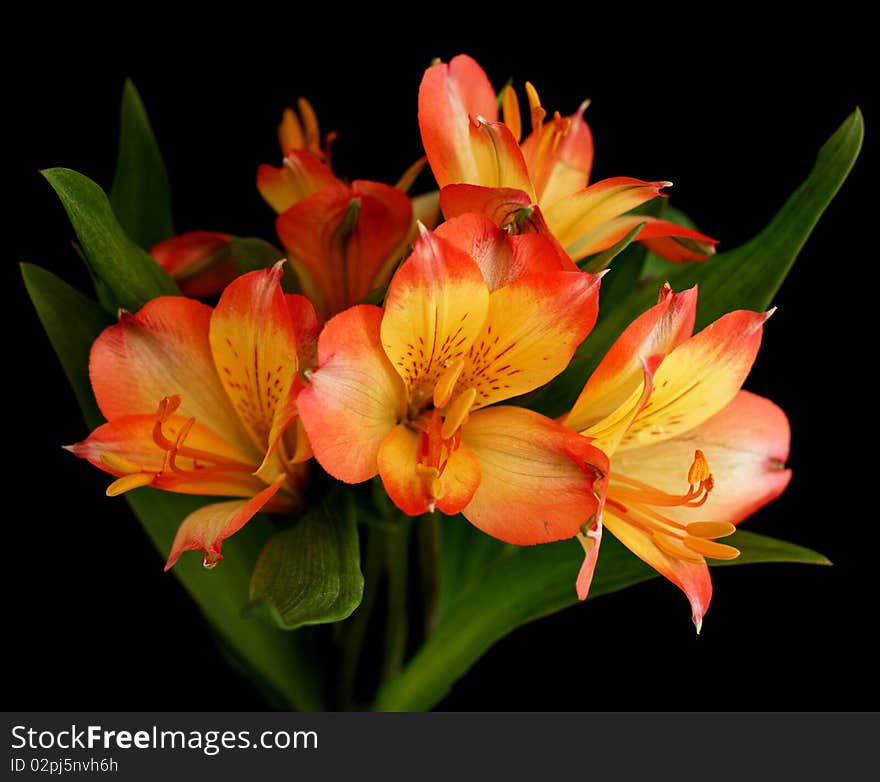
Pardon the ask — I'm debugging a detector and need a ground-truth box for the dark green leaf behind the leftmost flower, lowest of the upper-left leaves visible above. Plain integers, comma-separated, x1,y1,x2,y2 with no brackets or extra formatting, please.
21,263,111,427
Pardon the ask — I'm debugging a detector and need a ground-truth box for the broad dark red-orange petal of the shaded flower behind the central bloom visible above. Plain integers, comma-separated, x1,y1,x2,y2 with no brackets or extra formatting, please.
276,180,412,315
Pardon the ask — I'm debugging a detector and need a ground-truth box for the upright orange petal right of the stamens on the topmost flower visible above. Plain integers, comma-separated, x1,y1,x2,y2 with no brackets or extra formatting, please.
522,104,593,207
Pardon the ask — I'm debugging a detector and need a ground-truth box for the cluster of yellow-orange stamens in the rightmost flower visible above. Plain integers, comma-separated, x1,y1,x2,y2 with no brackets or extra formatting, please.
606,450,739,563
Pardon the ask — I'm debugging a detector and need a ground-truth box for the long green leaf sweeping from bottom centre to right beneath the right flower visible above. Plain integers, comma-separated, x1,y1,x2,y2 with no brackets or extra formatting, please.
376,518,828,711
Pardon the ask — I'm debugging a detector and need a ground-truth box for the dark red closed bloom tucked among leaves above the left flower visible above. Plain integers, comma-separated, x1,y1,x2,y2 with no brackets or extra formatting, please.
150,231,239,298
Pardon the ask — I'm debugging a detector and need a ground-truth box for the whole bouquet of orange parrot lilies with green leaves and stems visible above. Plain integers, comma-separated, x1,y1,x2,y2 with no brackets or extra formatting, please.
24,55,862,710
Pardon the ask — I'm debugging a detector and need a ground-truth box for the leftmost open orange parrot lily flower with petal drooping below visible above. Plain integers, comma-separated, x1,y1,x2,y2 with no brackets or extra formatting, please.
68,263,318,570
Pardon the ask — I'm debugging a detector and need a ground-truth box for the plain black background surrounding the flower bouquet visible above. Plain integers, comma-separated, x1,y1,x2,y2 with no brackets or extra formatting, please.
3,13,877,710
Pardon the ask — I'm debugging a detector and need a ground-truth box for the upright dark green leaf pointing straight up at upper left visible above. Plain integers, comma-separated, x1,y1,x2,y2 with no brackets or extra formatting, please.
110,79,174,250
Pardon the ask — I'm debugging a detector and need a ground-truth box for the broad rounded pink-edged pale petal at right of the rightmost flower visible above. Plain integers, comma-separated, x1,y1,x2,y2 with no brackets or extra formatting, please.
614,391,791,524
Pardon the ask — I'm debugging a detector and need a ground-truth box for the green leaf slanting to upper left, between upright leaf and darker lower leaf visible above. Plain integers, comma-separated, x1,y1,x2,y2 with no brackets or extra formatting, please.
43,168,180,312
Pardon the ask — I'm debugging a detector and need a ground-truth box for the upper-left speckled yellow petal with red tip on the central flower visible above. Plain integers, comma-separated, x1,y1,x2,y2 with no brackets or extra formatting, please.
381,232,489,407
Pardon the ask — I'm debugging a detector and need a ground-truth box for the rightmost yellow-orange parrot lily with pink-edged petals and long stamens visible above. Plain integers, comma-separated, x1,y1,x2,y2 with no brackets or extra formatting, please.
561,286,791,632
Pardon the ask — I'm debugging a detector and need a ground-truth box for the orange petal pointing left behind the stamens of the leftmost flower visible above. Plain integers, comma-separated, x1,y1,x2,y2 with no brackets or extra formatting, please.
68,415,264,497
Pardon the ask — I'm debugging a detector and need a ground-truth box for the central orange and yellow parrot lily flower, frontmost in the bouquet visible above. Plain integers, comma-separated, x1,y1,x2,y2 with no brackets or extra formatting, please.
299,215,606,545
